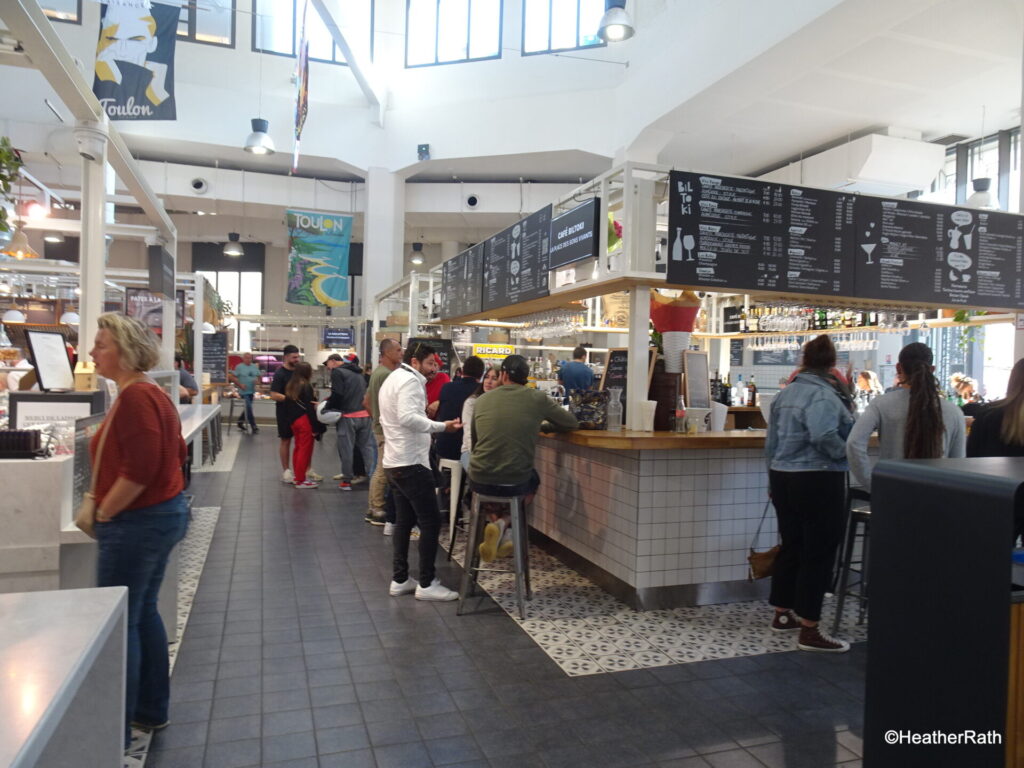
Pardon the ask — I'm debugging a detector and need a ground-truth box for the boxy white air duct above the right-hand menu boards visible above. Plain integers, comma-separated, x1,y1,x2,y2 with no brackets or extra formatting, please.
758,133,946,196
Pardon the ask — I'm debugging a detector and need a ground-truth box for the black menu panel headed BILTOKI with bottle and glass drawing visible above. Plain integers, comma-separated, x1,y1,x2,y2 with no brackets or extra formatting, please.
668,171,853,296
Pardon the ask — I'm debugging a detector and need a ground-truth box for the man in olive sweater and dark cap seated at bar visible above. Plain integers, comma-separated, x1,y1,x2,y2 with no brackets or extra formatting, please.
469,354,580,562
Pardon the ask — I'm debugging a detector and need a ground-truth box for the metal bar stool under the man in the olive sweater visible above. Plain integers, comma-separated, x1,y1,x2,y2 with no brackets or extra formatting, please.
456,480,534,620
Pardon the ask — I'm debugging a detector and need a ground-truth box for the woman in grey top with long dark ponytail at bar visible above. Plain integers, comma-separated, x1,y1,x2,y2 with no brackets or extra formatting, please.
846,342,967,490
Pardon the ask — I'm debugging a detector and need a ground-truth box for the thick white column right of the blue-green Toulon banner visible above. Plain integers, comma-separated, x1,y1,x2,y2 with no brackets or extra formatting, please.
360,168,406,321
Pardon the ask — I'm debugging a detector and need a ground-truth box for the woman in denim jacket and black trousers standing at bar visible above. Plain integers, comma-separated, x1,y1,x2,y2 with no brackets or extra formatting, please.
765,336,853,653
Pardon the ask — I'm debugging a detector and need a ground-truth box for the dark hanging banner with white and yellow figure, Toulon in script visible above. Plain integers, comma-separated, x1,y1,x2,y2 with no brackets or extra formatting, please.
92,3,181,120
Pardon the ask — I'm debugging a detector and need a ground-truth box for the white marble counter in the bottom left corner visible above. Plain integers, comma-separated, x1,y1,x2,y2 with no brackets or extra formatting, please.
0,587,128,768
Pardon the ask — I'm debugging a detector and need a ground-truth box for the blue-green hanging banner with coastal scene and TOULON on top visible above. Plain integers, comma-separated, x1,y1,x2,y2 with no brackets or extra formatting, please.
285,210,352,306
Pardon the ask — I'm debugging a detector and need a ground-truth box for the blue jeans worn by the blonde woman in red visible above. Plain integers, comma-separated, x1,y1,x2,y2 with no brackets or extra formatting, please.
96,494,188,746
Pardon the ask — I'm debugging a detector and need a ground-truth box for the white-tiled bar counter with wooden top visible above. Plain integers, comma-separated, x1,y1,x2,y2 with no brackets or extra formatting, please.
530,430,776,609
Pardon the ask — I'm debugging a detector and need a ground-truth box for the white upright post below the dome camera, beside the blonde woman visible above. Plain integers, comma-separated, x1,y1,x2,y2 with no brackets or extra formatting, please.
75,117,106,360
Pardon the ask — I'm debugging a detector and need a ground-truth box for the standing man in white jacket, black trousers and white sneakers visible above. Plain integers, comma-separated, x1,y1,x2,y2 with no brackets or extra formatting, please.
378,344,462,601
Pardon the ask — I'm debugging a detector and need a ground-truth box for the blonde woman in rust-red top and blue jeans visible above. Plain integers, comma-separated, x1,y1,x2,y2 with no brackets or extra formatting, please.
89,312,188,746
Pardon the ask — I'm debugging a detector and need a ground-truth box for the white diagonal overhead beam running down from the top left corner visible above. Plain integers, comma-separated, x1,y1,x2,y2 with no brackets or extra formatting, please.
0,0,176,240
